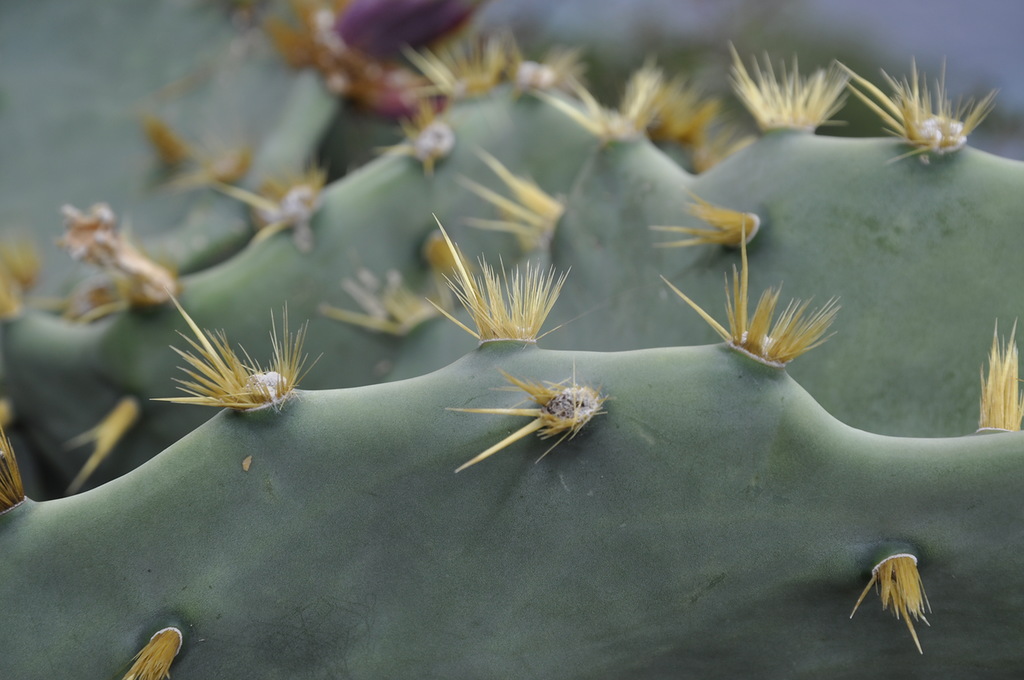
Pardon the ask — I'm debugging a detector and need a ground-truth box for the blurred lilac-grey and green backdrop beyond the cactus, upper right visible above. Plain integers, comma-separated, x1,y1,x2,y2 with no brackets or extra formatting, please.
479,0,1024,159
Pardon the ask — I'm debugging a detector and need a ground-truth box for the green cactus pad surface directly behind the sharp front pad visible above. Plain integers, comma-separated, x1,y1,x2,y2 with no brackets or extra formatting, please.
4,78,1024,489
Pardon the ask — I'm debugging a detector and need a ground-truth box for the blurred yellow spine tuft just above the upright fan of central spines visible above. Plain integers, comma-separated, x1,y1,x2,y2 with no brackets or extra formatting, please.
459,150,565,253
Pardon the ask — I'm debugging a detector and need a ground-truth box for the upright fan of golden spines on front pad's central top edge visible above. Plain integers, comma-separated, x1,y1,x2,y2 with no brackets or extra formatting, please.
434,222,566,343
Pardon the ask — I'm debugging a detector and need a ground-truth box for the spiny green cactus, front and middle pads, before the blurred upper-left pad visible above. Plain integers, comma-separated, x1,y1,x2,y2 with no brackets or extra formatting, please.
0,0,1024,679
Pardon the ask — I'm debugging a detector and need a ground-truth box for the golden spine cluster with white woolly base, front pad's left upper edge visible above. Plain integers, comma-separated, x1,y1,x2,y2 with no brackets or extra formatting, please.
157,300,307,411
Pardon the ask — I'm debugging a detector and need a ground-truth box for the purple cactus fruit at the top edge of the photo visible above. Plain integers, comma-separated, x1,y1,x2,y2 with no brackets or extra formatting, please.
335,0,475,59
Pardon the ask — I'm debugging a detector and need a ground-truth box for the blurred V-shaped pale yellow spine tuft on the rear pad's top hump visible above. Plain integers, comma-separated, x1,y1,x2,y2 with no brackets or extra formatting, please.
540,65,665,142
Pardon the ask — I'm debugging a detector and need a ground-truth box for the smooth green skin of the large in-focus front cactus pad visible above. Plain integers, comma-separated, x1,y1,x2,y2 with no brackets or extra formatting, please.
0,343,1024,680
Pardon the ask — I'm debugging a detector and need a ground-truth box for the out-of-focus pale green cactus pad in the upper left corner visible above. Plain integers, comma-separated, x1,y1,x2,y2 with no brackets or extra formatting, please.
0,0,311,280
